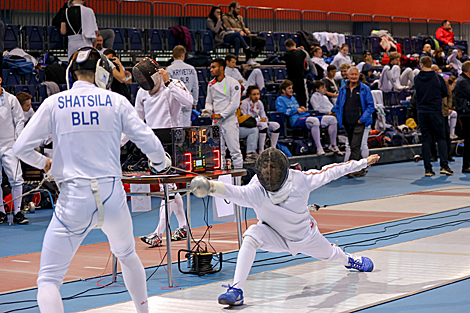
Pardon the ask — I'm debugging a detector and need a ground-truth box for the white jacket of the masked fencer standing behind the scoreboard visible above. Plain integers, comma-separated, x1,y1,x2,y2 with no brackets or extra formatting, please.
135,79,194,129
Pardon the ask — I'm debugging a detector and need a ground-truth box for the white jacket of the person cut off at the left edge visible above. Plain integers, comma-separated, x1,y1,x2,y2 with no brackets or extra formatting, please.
0,88,24,153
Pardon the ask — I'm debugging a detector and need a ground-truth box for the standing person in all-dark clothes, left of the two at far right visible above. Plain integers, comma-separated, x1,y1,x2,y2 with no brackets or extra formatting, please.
414,56,454,176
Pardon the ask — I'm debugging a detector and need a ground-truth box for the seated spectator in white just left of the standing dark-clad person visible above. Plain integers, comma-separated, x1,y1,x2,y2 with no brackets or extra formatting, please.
379,52,418,92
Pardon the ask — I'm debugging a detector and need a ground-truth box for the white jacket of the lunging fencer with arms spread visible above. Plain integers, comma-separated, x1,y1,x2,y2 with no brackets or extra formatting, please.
212,159,367,242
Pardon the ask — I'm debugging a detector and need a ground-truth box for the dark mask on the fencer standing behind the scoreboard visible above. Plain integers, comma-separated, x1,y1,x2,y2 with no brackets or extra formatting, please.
132,58,162,94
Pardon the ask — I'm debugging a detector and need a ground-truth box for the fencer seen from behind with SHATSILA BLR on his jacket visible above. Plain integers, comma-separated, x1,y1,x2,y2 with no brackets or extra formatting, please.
13,48,171,313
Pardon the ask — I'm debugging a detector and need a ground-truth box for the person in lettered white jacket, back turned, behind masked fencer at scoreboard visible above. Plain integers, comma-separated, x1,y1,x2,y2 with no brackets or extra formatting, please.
166,46,199,127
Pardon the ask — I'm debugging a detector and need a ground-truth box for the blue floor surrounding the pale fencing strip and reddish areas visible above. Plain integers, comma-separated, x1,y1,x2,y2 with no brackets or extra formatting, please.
0,158,470,312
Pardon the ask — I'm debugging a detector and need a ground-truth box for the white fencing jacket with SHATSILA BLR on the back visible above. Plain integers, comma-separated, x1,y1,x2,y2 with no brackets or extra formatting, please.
13,81,165,183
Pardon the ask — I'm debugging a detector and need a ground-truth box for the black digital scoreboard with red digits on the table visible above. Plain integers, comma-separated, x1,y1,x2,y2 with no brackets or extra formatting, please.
154,125,222,172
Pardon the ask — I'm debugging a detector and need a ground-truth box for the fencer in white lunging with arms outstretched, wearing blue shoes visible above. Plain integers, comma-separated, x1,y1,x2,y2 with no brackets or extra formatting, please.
191,148,380,306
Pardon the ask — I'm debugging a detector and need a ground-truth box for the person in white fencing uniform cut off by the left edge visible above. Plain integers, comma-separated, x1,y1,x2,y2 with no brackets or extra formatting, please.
0,84,29,224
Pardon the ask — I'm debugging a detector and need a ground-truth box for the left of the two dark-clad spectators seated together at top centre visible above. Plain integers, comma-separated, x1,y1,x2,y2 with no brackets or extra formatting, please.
206,6,254,57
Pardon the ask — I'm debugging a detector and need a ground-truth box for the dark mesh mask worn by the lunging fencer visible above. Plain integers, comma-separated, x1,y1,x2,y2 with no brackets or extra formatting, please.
255,148,289,192
